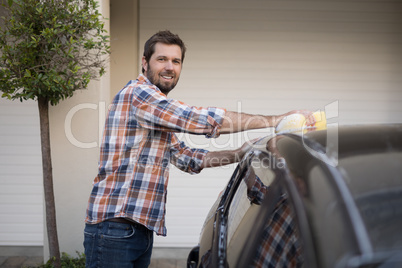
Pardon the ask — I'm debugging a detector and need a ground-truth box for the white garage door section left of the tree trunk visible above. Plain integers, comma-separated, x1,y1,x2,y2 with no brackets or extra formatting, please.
0,99,43,246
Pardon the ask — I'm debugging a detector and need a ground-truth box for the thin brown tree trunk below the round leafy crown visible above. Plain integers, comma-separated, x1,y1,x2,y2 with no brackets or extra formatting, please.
38,97,61,267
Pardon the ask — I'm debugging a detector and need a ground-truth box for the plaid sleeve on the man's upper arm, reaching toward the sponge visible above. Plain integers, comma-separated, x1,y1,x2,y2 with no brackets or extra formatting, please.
132,85,226,138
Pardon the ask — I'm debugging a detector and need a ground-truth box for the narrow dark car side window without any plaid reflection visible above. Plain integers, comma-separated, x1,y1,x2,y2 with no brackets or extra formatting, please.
304,165,358,267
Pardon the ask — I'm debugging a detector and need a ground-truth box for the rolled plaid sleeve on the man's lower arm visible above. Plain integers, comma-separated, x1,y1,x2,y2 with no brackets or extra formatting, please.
170,133,208,174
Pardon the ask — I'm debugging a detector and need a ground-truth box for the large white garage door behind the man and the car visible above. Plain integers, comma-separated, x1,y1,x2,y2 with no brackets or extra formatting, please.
139,0,402,246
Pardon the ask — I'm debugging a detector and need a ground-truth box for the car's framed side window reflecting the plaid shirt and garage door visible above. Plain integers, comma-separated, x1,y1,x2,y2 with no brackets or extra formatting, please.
207,150,303,267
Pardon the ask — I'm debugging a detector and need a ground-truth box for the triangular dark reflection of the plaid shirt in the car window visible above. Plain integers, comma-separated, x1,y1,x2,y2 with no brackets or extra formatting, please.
253,195,303,268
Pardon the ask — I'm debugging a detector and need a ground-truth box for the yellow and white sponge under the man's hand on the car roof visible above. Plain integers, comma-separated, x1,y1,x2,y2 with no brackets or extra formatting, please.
275,111,327,134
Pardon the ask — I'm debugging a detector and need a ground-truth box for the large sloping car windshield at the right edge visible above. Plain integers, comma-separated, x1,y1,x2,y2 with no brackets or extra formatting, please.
339,152,402,251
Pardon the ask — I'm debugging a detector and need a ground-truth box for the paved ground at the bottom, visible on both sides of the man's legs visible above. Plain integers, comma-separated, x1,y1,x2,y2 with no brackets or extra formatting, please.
0,256,187,268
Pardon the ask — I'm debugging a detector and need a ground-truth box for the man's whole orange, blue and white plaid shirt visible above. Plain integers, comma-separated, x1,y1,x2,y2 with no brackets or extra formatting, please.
86,75,225,236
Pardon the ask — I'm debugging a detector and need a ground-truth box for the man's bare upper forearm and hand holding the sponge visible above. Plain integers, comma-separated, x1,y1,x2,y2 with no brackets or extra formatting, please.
220,110,315,134
